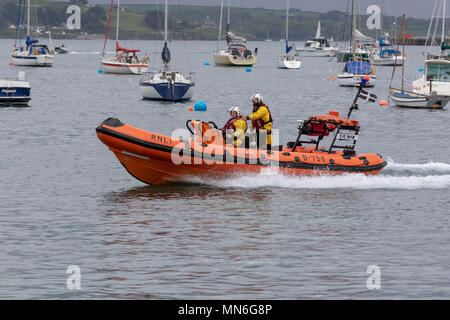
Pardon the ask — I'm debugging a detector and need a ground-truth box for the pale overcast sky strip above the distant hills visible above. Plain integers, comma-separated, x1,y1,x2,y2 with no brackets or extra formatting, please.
89,0,442,18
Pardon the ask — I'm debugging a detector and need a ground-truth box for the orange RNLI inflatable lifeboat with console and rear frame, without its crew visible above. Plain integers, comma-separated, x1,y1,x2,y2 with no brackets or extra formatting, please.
96,86,386,185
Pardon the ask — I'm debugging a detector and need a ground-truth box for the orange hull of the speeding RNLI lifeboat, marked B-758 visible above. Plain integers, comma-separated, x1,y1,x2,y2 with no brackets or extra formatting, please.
96,118,386,184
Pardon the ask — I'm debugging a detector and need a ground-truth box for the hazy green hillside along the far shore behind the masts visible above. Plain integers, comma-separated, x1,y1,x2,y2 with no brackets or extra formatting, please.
0,0,440,41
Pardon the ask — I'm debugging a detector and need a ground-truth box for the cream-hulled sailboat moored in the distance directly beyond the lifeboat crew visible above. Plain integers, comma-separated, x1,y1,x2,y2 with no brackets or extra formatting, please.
213,0,258,66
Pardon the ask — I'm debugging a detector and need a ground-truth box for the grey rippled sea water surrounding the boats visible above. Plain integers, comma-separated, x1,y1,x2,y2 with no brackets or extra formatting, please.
0,40,450,299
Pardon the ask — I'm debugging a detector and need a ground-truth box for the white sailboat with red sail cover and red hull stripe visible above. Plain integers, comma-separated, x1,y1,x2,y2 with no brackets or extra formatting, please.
100,0,149,74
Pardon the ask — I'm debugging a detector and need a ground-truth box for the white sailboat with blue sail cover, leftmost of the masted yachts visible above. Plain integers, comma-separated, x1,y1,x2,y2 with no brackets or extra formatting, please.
11,0,55,67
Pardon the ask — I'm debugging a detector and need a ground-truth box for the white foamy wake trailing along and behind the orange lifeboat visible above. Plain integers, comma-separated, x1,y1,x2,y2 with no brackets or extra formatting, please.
185,160,450,190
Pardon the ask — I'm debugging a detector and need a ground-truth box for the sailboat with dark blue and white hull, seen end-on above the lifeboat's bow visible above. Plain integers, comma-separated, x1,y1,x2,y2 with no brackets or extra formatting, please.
139,0,195,101
